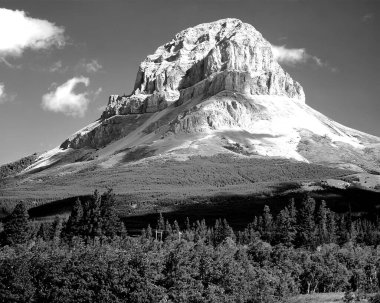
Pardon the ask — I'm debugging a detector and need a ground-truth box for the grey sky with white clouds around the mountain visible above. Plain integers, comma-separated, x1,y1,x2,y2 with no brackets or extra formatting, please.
0,0,380,164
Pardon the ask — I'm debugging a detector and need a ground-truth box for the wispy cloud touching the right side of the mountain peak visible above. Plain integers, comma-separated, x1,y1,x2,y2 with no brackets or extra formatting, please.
272,45,328,67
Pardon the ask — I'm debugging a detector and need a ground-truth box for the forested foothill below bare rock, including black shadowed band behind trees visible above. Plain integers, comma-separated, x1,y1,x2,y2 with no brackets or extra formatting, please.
0,155,380,233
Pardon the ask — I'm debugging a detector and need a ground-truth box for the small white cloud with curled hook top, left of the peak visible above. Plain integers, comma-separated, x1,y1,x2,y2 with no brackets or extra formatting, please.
42,76,90,117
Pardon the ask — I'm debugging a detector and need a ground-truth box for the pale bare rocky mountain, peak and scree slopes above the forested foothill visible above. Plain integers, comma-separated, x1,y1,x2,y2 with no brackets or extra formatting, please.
28,19,380,171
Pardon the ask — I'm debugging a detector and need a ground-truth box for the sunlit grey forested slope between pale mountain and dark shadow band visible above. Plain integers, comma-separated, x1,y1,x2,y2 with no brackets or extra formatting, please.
0,155,351,208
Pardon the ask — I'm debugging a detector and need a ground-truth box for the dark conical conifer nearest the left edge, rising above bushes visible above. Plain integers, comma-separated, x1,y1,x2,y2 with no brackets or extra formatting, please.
4,202,29,245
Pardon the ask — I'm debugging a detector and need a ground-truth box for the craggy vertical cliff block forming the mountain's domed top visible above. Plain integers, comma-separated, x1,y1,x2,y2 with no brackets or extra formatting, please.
102,19,305,119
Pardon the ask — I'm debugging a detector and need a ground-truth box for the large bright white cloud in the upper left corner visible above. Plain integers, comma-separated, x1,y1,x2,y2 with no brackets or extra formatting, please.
0,8,65,58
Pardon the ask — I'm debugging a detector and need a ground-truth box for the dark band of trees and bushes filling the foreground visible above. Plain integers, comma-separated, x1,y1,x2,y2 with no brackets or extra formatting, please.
0,190,380,303
